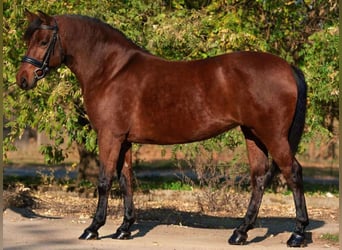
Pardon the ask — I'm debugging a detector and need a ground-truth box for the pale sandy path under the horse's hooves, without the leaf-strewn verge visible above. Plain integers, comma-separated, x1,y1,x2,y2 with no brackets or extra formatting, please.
3,205,339,250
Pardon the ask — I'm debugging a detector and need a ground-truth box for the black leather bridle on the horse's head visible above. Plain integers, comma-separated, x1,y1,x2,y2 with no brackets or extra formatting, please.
21,20,63,81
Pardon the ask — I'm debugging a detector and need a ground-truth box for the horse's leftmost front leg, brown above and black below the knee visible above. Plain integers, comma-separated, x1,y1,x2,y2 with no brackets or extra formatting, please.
79,137,121,240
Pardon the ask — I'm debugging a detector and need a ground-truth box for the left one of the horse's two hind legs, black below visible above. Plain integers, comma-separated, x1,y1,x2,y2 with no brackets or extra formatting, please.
228,127,276,245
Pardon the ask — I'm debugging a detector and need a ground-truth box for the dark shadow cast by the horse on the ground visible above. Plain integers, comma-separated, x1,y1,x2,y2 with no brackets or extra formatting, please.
100,208,325,244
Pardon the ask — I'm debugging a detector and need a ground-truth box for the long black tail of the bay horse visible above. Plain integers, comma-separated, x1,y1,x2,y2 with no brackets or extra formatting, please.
289,66,307,155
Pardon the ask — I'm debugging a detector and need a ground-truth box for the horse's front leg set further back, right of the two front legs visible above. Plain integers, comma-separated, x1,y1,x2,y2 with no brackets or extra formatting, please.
112,142,136,239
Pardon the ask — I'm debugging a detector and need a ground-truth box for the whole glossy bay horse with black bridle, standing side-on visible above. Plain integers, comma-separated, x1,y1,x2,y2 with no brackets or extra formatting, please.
16,10,309,247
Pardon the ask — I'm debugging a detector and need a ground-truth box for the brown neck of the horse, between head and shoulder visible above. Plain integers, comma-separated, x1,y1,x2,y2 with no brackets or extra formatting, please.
56,16,139,91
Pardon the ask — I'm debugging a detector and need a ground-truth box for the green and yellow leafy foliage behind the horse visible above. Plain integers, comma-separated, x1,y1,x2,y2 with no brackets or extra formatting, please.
3,0,339,170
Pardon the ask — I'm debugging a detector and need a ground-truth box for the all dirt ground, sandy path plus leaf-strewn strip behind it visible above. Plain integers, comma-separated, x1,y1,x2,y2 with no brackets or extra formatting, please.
3,190,339,250
